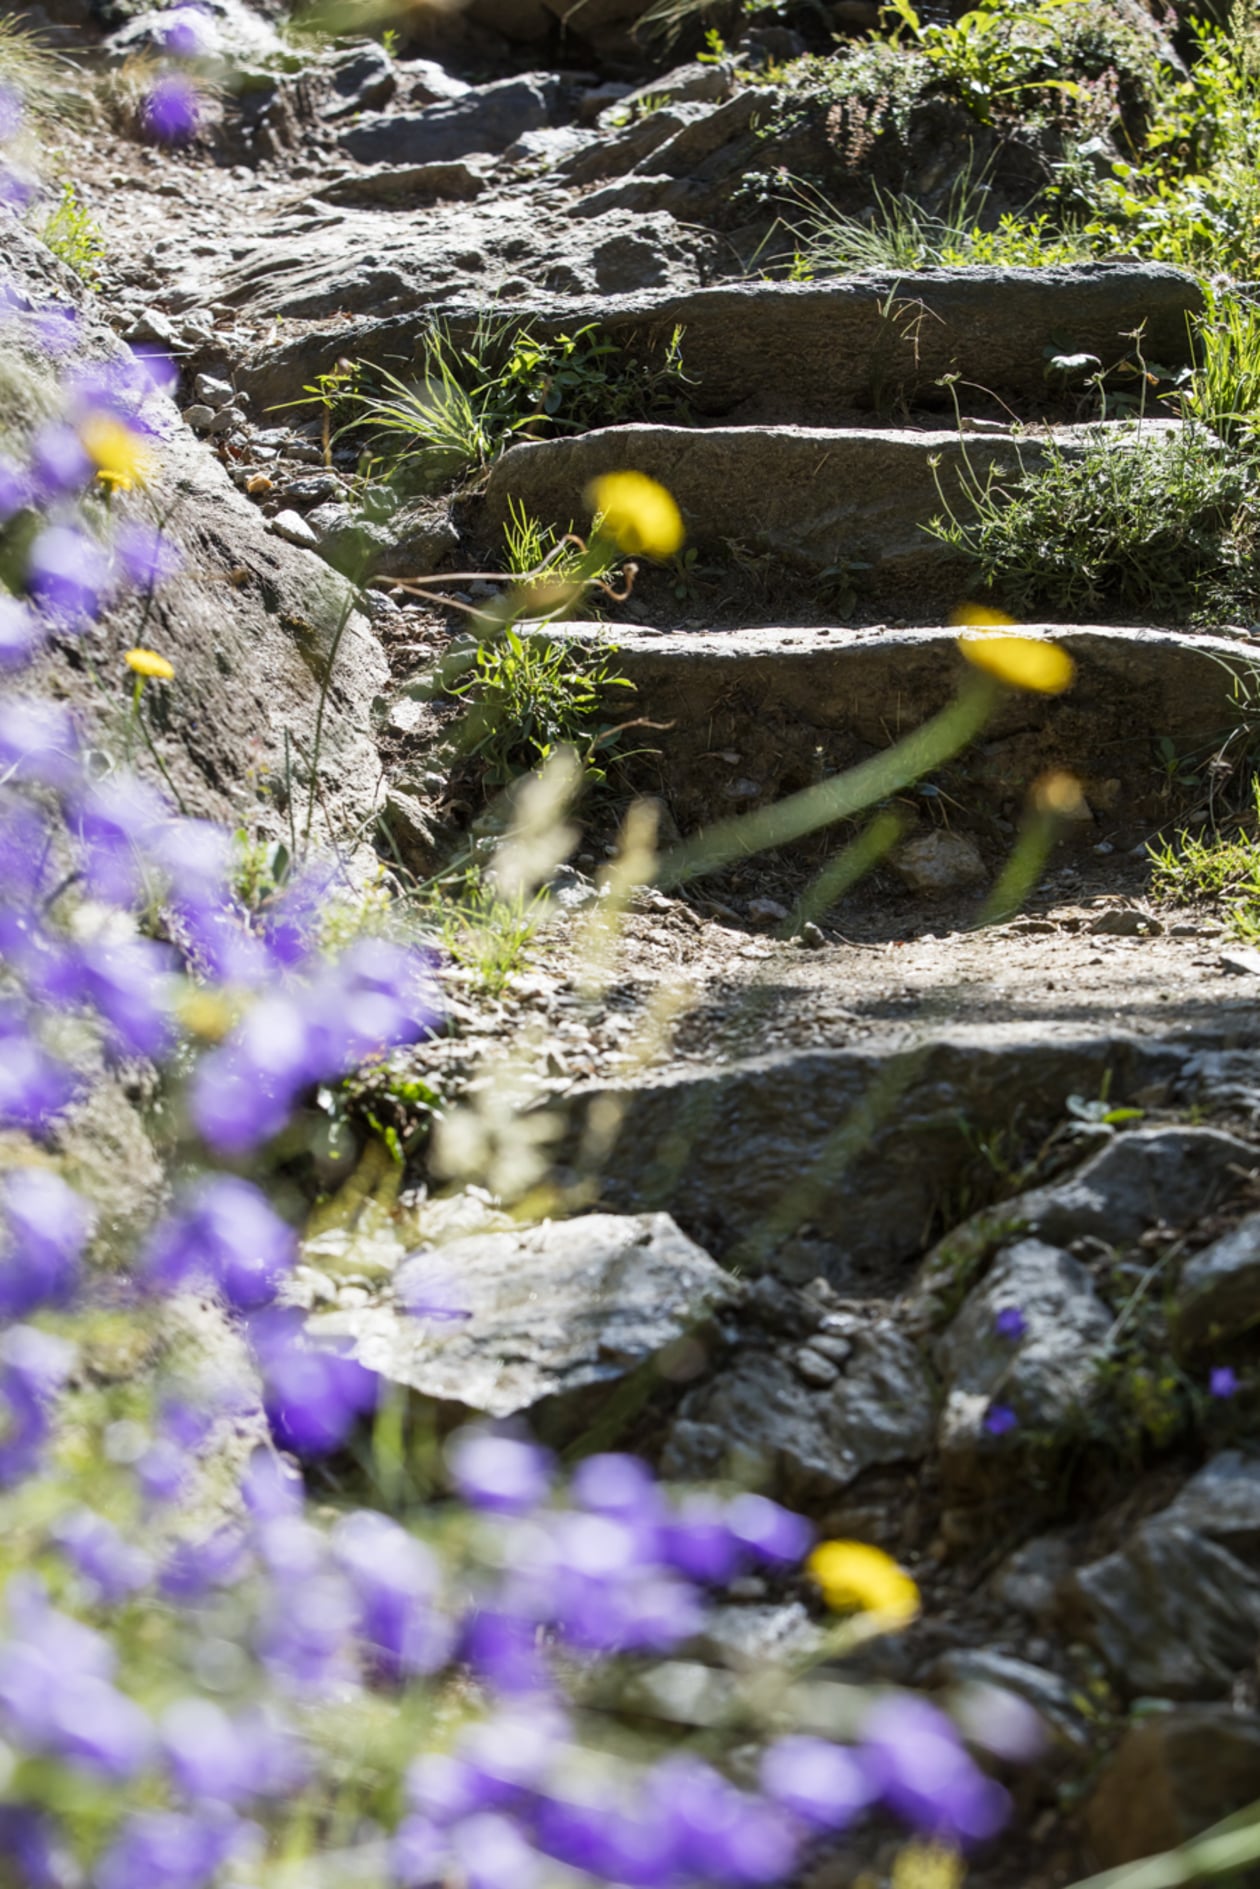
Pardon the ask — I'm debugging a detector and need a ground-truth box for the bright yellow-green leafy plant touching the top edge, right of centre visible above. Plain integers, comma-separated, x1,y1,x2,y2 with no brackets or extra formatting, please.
884,0,1081,125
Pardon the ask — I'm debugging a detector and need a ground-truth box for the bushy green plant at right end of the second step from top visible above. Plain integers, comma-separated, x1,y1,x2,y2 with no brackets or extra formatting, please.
926,425,1260,621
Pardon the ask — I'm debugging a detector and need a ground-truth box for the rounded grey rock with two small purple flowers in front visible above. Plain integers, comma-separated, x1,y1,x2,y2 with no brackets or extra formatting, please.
933,1239,1113,1494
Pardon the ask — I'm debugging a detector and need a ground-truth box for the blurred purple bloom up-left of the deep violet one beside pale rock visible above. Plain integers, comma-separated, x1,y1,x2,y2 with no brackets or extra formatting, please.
140,1175,297,1311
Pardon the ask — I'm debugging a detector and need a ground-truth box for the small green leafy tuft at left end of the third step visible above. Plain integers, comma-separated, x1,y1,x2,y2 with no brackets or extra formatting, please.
451,629,635,786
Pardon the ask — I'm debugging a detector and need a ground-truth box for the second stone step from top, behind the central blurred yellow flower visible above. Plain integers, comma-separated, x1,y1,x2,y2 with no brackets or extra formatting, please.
472,419,1177,621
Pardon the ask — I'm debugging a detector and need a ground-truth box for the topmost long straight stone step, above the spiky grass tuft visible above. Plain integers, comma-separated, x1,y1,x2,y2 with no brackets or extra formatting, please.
230,258,1203,425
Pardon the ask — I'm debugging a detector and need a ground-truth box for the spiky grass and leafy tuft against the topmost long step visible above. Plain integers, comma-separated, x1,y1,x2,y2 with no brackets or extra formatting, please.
342,319,686,485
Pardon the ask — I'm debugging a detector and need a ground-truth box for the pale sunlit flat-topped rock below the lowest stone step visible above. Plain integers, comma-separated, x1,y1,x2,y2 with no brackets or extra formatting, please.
310,1213,739,1436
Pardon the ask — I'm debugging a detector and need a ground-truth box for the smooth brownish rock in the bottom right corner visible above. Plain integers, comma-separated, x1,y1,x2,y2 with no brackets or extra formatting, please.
1084,1706,1260,1868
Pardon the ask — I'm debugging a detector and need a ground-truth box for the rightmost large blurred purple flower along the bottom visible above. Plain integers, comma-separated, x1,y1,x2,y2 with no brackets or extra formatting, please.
860,1693,1009,1844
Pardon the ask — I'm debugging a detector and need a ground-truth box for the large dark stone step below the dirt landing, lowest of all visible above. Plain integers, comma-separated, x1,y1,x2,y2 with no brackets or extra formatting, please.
551,1020,1260,1298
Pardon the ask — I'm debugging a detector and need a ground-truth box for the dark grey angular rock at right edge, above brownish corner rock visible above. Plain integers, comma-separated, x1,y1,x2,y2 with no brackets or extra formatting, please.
1062,1451,1260,1698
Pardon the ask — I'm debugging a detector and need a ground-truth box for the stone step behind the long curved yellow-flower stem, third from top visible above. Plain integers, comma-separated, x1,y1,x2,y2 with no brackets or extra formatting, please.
546,623,1256,834
